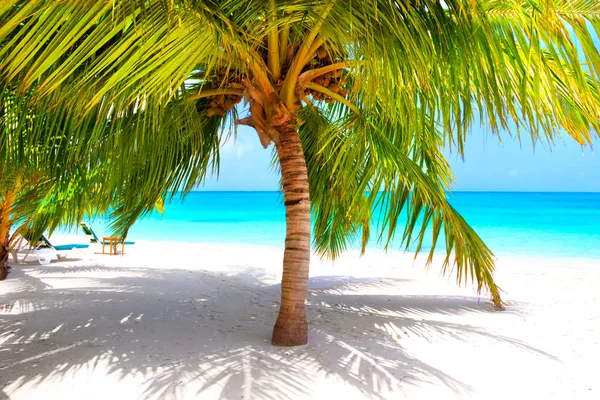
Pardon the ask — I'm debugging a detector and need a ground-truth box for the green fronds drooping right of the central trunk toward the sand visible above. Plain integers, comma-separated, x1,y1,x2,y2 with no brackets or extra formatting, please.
301,102,501,307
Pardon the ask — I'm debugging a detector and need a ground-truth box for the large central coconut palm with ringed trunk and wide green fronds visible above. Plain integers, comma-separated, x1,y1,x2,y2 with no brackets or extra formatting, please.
0,0,600,345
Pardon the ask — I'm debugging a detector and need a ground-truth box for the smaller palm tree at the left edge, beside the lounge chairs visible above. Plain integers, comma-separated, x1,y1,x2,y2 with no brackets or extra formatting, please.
0,89,91,280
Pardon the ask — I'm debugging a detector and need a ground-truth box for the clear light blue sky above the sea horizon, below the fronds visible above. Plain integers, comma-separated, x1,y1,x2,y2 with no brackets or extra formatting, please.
200,127,600,192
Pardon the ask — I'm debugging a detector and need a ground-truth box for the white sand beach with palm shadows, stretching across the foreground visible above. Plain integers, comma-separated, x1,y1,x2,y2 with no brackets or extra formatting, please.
0,242,600,400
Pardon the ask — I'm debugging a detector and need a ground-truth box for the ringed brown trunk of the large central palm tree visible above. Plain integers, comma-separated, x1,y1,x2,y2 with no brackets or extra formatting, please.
272,117,311,346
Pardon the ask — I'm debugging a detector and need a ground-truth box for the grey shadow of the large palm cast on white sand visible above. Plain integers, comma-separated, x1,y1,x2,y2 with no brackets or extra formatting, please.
0,265,552,399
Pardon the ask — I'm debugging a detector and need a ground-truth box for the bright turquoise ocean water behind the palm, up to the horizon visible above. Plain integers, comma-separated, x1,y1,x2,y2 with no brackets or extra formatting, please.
92,192,600,259
